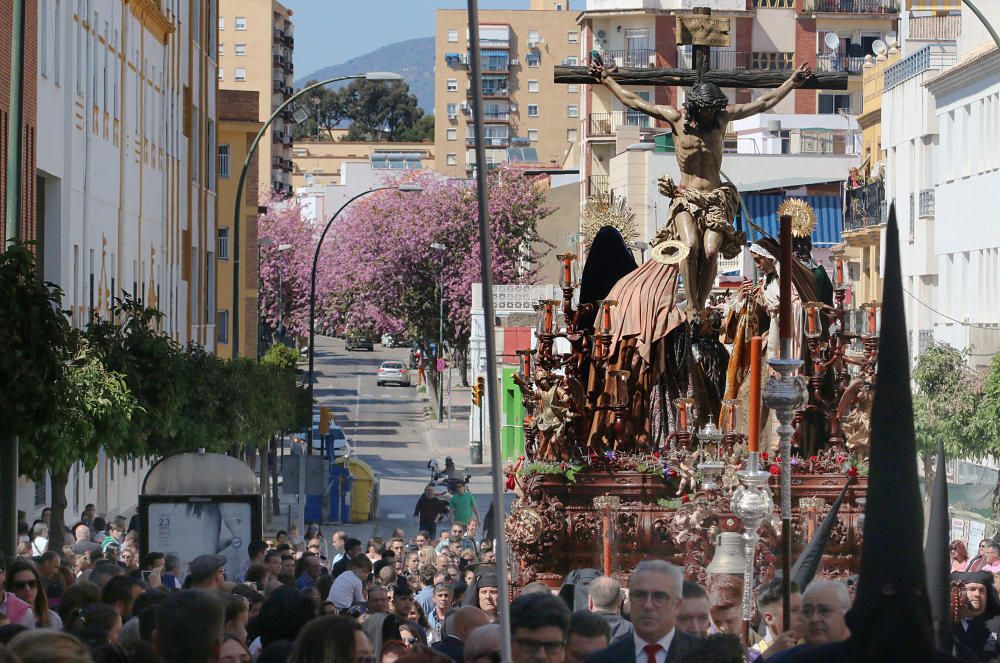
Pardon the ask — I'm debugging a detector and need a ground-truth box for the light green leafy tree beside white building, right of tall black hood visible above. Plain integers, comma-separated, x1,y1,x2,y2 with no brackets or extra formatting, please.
913,343,990,495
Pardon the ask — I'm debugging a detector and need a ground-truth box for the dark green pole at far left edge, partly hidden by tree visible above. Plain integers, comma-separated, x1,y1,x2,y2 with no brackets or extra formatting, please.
0,0,25,559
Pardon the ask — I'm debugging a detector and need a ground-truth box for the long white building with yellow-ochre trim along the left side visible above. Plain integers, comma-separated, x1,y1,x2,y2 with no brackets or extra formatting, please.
28,0,218,518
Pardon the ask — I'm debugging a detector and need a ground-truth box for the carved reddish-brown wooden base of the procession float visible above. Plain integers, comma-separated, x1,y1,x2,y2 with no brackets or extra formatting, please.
507,471,868,587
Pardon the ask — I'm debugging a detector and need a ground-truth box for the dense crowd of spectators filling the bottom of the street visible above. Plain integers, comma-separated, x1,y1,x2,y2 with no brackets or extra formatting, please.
0,498,1000,663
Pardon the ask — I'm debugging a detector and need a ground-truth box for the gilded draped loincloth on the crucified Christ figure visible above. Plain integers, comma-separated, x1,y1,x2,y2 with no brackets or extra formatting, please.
652,177,747,260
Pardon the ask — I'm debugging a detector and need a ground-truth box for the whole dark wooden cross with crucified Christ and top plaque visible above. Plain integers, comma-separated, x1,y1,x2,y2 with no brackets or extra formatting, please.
555,7,847,317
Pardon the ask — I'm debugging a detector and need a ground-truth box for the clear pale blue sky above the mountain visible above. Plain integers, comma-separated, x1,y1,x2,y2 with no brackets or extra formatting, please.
283,0,530,75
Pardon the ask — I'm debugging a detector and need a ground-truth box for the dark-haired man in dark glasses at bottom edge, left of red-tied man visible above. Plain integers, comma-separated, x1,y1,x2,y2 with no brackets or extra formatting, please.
510,593,572,663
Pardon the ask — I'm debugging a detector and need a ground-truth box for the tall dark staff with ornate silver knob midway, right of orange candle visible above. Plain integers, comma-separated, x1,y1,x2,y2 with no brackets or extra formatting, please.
764,214,809,629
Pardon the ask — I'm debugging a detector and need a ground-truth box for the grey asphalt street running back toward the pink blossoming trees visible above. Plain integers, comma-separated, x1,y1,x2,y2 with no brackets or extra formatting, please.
302,336,491,540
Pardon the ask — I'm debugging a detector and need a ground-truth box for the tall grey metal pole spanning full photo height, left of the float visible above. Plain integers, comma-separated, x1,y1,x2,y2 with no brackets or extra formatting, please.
468,5,512,663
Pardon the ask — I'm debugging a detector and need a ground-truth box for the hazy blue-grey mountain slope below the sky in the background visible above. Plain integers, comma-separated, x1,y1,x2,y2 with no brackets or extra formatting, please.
295,37,434,114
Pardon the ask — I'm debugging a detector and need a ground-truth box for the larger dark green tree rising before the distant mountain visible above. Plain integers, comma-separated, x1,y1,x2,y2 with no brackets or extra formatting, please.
344,79,424,141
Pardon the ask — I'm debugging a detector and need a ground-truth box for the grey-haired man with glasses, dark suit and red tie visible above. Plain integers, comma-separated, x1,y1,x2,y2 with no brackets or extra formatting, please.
586,560,696,663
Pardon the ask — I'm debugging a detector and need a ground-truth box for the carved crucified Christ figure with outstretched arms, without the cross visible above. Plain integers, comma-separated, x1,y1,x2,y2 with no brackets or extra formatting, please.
590,62,811,319
